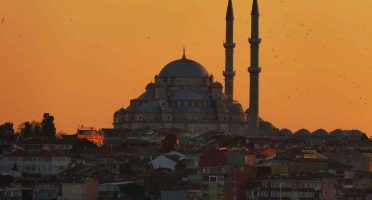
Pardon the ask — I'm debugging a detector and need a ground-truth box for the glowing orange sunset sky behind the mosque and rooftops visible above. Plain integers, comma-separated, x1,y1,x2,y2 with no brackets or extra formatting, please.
0,0,372,135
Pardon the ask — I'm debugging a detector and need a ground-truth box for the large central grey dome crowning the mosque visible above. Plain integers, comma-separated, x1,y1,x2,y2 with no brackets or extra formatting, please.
159,58,208,77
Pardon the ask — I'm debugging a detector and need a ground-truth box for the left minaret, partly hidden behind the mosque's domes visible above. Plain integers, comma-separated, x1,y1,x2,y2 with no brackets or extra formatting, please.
223,0,235,100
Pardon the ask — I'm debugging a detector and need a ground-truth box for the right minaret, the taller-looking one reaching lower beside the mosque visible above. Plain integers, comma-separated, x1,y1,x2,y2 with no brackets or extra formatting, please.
248,0,261,134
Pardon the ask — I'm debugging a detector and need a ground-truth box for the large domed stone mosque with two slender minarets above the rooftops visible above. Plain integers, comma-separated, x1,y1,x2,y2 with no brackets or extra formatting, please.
113,0,276,136
